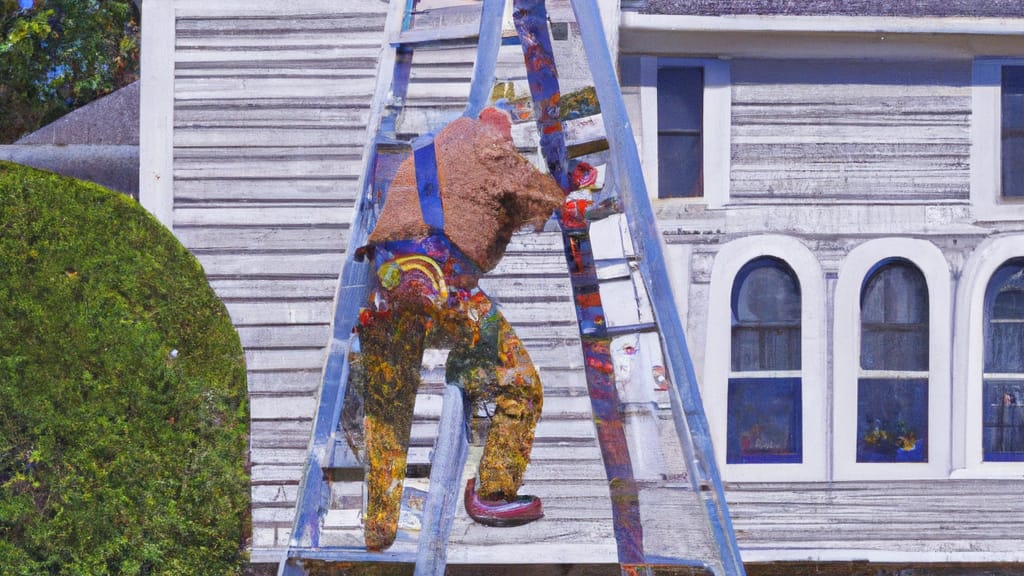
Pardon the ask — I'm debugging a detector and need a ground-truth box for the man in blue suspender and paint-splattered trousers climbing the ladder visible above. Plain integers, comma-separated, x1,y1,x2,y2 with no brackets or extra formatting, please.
355,109,564,550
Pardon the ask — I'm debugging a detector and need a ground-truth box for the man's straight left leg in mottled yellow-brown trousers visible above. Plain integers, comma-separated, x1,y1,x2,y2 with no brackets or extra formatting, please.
358,312,428,550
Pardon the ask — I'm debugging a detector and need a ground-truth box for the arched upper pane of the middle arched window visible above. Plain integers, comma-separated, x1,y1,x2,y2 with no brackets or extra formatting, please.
860,260,929,370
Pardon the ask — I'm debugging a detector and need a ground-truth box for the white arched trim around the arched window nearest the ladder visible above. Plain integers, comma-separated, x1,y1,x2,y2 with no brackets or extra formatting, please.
701,235,828,482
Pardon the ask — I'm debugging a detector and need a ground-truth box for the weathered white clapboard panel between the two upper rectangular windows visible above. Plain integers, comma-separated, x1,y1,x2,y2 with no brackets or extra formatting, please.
730,60,971,200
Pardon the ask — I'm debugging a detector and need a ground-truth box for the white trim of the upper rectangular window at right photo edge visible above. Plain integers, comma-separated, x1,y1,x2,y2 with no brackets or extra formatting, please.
971,58,1024,220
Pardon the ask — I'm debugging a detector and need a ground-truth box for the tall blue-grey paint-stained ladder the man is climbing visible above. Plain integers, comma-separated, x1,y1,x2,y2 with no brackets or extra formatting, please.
279,0,743,576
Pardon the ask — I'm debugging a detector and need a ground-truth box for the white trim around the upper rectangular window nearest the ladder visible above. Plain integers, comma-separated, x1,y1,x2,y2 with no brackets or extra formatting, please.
640,56,732,208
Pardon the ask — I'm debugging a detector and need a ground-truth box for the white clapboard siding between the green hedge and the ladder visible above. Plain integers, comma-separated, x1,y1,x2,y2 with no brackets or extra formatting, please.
172,0,387,558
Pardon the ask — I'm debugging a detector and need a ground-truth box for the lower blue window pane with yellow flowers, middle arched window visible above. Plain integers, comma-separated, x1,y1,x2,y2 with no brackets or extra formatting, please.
857,378,928,462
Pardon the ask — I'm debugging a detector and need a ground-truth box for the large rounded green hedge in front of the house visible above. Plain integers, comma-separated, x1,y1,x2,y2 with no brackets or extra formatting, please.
0,162,249,576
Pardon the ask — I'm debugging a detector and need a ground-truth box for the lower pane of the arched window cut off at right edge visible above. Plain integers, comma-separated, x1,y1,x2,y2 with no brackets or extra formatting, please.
982,379,1024,462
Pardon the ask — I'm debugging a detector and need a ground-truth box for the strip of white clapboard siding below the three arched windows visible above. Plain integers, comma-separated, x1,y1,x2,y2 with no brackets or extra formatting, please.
726,480,1024,554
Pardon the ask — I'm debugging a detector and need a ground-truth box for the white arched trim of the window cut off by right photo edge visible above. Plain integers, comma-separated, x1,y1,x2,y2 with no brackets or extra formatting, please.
952,235,1024,478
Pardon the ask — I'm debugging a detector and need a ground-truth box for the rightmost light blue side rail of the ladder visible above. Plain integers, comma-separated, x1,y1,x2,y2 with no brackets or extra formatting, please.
571,0,744,575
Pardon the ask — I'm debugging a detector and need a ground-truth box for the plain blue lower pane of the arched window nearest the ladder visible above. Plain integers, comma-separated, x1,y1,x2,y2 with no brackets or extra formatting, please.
725,378,804,464
